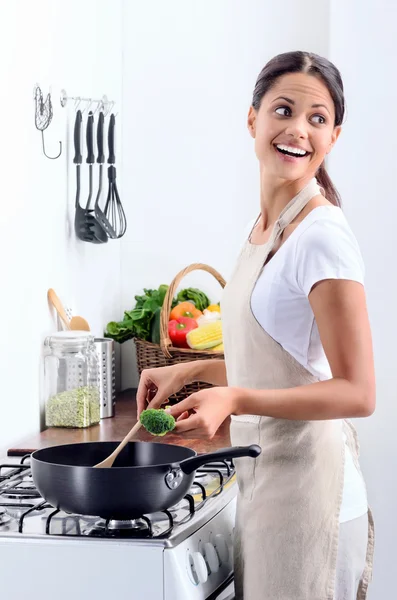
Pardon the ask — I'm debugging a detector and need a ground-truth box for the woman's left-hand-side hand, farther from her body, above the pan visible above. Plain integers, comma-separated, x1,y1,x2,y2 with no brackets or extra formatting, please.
136,363,187,419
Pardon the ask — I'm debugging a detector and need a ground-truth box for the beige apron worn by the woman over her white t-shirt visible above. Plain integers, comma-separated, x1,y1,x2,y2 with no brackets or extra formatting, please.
222,179,374,600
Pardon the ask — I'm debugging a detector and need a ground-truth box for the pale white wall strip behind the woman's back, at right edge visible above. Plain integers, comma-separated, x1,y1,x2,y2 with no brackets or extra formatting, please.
330,0,397,600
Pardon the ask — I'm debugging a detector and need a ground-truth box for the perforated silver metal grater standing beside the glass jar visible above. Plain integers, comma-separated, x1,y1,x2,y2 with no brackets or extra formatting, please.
94,338,116,419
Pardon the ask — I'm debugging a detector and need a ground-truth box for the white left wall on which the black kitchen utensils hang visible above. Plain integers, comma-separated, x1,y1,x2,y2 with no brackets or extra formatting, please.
0,0,122,456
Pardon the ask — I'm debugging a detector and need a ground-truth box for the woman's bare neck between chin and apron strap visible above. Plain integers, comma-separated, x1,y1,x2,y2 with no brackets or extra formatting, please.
260,169,313,231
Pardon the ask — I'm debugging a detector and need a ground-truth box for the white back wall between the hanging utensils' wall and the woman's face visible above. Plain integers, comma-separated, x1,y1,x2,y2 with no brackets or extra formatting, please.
120,0,328,387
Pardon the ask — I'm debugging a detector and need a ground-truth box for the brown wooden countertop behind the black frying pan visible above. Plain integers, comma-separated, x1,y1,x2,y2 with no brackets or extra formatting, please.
7,389,231,456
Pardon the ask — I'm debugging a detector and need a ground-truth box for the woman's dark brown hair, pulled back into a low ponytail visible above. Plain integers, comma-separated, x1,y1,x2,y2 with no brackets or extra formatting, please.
252,51,345,206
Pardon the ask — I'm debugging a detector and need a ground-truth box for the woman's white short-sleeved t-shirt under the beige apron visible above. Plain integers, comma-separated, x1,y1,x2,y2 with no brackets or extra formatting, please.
247,206,367,523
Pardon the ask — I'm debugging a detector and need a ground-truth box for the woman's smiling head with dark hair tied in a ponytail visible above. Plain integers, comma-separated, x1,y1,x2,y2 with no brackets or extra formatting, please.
248,67,345,211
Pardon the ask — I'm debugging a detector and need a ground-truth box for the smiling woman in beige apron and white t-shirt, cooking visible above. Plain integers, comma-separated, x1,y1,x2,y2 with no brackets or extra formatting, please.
137,52,375,600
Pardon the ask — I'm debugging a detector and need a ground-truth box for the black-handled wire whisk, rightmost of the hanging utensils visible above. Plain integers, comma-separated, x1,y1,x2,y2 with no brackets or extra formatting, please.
104,114,127,238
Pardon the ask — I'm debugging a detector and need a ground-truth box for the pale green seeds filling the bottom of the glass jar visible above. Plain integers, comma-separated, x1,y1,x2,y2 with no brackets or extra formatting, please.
46,386,100,427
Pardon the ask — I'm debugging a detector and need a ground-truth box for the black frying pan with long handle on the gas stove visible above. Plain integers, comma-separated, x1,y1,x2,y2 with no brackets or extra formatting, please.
31,442,261,520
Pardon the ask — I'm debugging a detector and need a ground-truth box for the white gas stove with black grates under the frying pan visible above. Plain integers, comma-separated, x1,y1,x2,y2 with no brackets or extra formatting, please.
0,455,237,600
